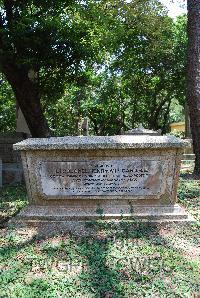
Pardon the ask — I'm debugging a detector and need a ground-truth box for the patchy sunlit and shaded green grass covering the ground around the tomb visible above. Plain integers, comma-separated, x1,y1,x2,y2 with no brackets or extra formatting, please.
0,175,200,298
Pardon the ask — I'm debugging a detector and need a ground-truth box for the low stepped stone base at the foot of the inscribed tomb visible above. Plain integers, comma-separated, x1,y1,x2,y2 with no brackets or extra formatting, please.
10,204,194,225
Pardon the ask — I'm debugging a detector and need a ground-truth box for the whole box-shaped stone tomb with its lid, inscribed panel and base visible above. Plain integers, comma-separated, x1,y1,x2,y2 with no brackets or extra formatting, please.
11,135,192,224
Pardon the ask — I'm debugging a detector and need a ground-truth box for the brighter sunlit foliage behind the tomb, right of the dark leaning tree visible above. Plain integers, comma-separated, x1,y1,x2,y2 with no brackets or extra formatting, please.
45,1,187,135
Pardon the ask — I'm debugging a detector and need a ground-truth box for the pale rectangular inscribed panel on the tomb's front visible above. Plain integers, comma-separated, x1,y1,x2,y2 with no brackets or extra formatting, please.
40,159,163,196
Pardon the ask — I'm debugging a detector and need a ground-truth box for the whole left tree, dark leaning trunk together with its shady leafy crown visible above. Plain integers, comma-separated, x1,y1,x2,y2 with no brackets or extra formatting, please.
0,0,111,137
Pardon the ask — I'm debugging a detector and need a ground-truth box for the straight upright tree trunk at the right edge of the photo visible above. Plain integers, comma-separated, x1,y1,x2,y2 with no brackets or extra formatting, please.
187,0,200,177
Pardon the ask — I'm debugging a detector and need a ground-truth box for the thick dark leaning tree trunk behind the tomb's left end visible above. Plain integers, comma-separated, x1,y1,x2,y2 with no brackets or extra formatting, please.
3,63,50,138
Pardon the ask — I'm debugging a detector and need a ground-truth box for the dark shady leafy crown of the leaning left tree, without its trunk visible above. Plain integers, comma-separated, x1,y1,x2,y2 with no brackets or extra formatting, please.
0,0,112,101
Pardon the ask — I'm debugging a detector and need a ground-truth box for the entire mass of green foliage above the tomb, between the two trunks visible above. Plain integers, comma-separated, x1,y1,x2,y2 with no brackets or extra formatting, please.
1,0,187,135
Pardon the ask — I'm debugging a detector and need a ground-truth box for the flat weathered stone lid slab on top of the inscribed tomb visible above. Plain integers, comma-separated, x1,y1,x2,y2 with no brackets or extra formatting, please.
13,135,189,151
